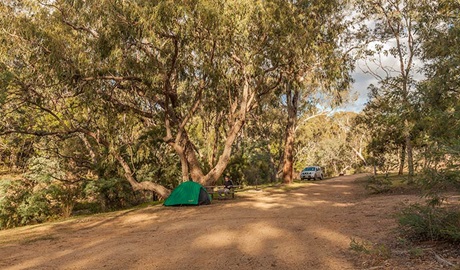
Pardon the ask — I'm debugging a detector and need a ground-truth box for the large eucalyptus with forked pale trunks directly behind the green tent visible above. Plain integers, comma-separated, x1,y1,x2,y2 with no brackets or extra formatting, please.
86,1,296,187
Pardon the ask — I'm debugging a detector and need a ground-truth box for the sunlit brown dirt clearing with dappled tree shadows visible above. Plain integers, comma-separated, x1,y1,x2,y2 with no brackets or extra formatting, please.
0,175,460,270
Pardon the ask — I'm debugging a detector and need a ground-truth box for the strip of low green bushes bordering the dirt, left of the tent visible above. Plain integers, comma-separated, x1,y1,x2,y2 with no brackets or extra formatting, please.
0,178,154,229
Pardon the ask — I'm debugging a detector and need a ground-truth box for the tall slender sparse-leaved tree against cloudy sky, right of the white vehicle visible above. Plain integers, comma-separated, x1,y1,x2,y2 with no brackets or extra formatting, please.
358,0,431,180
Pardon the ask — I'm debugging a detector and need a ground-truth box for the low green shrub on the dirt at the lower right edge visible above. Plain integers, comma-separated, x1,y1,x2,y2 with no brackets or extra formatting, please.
398,204,460,243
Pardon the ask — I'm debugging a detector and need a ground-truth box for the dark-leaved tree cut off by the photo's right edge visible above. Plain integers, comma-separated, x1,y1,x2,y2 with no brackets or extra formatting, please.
420,1,460,148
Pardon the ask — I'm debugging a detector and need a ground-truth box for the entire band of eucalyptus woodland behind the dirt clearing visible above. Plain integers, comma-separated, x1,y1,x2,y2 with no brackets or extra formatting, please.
0,0,460,233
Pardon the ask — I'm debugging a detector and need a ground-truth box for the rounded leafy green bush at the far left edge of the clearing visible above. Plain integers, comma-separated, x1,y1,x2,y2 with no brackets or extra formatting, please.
0,158,88,228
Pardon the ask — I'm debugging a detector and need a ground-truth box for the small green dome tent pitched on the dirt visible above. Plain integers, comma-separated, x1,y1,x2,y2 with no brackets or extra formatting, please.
163,180,211,206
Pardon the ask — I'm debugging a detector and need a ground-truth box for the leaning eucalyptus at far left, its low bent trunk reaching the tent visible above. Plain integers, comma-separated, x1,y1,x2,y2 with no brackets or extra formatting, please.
1,1,178,196
